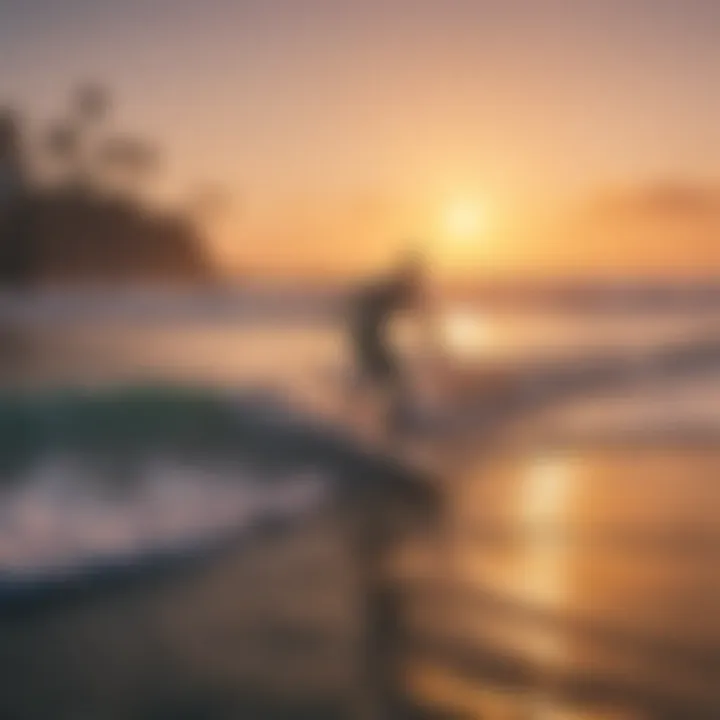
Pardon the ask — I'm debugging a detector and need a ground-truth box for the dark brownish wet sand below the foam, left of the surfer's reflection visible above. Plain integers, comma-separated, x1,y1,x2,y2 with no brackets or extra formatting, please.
0,518,360,720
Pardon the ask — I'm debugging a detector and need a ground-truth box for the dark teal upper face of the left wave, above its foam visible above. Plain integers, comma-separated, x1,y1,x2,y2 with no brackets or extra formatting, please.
0,385,350,480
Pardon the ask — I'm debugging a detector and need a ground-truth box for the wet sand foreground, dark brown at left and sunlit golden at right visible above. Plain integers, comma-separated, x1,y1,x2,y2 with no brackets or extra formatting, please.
0,449,720,720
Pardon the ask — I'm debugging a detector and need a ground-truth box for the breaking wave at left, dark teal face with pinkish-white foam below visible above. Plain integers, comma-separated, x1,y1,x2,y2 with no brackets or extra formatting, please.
0,386,329,594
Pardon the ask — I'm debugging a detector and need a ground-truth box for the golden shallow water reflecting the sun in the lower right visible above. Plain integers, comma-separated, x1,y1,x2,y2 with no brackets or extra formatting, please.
404,447,720,718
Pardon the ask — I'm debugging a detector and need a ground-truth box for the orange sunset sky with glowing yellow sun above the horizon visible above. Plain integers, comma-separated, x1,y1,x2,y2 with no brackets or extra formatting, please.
0,0,720,273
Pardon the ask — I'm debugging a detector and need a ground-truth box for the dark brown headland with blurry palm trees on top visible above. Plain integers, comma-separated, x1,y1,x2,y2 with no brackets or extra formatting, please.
0,86,216,287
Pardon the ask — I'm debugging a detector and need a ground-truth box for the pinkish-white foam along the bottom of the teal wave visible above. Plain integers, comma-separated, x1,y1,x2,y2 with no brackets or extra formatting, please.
0,456,327,572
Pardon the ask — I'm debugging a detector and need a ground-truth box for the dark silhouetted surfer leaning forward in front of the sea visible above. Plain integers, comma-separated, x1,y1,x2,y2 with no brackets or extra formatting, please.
350,253,425,434
